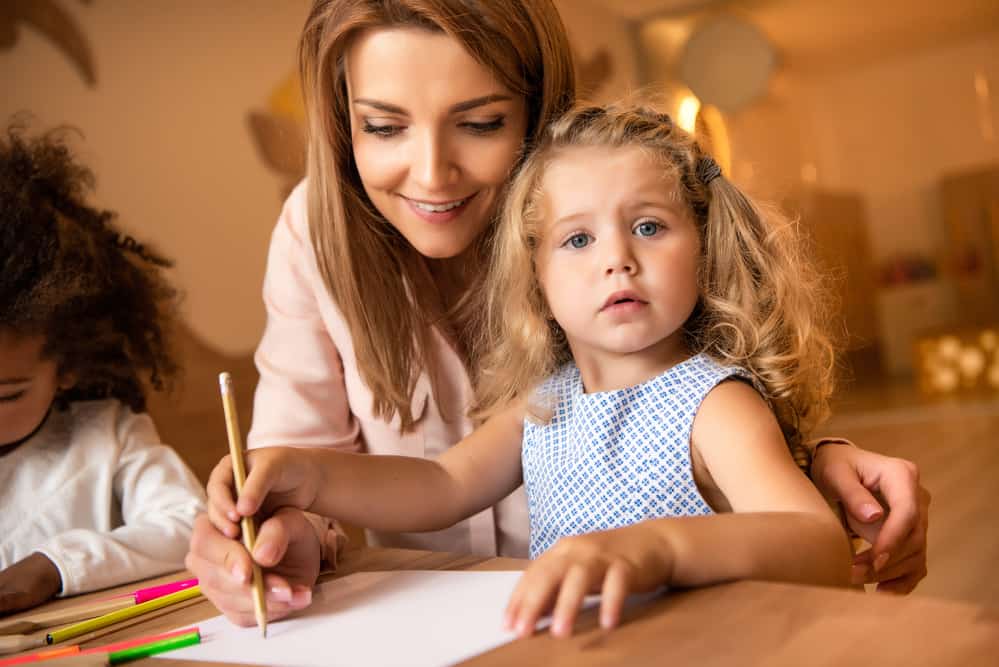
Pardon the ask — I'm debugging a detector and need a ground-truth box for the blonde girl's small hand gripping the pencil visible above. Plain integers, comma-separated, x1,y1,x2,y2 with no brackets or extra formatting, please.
207,447,320,549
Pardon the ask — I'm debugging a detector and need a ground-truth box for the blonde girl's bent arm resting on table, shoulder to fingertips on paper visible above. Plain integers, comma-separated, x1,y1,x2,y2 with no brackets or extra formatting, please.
505,382,851,636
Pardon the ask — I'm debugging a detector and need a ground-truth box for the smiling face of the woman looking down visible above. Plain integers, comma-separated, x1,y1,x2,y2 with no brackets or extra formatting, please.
346,28,527,258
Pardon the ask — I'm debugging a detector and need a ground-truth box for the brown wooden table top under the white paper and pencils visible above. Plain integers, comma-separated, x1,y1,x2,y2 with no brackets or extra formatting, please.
3,549,999,667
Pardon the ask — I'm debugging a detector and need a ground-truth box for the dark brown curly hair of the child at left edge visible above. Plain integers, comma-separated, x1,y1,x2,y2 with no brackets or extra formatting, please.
0,123,178,411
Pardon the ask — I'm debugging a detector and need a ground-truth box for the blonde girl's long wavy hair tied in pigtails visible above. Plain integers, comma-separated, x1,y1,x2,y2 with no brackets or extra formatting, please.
472,105,835,447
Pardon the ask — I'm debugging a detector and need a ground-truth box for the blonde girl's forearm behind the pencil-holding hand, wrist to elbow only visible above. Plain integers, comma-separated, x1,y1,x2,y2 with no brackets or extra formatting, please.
307,450,465,532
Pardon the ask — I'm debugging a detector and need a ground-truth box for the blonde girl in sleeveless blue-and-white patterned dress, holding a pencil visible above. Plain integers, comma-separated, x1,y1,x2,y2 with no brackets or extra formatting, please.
209,100,850,635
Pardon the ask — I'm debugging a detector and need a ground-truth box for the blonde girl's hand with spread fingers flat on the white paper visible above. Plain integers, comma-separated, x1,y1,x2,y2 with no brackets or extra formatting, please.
504,523,673,637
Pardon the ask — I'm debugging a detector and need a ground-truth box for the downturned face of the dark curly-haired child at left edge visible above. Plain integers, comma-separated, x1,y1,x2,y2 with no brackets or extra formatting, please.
0,329,65,451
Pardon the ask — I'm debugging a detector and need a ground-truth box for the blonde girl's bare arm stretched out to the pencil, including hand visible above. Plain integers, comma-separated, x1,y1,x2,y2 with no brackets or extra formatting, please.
230,405,524,532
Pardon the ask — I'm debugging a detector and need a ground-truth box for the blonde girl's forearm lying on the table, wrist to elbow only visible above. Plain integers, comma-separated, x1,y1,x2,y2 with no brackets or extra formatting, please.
649,512,851,586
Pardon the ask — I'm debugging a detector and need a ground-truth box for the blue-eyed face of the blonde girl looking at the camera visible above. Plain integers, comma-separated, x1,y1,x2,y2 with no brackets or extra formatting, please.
537,147,701,391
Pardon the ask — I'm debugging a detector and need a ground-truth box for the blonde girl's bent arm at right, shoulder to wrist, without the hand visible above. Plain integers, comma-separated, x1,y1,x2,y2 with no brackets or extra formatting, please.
668,382,851,585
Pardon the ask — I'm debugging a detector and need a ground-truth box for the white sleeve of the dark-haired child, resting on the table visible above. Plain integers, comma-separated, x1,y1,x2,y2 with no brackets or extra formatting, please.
40,410,205,596
